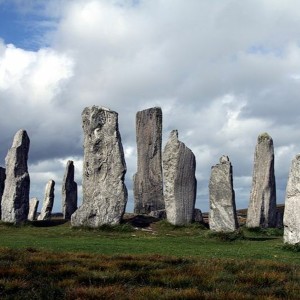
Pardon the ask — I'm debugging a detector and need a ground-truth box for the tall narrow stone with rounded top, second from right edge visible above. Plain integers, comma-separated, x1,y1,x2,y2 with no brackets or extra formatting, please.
246,133,277,228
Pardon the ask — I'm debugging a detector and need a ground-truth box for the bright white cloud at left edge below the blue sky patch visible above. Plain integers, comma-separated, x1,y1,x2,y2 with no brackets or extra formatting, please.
0,44,73,105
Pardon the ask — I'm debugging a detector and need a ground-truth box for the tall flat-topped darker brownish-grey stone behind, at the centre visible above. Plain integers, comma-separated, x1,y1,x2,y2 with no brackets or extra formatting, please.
133,107,165,214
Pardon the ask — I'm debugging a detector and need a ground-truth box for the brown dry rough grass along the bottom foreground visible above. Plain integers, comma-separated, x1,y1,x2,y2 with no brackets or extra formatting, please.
0,248,300,300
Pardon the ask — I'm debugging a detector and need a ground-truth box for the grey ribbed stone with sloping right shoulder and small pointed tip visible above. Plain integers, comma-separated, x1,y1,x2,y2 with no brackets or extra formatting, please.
163,130,197,225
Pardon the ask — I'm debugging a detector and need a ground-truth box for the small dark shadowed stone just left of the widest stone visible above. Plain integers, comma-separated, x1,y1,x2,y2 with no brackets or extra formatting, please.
62,160,77,220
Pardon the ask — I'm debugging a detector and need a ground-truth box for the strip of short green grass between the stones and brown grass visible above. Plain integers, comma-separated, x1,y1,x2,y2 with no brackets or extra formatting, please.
0,221,300,264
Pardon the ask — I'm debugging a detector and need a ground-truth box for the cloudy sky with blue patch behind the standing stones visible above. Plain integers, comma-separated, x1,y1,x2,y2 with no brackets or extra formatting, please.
0,0,300,212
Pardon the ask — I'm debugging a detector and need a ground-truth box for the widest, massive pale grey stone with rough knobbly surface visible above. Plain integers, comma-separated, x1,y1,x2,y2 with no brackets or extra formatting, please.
71,106,127,227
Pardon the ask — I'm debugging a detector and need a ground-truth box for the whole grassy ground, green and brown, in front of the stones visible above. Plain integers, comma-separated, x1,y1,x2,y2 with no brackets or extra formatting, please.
0,220,300,299
